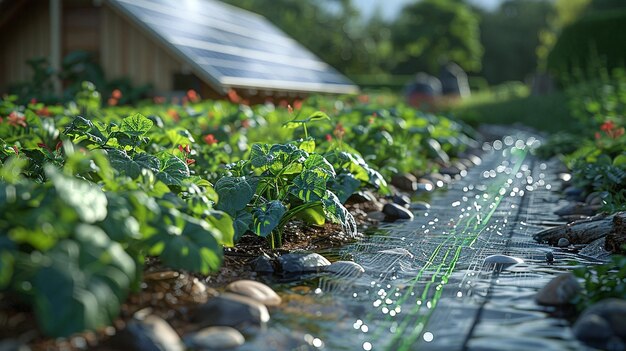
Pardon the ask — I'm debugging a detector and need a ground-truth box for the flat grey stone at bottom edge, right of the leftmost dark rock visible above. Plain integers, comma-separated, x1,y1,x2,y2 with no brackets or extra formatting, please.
183,327,246,350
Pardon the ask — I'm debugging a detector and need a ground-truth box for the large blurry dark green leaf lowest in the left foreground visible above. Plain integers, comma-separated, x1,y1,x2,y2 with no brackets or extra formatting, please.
32,225,136,336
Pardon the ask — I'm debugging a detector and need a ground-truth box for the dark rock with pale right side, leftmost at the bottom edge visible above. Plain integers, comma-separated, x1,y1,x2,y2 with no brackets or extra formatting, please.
110,310,185,351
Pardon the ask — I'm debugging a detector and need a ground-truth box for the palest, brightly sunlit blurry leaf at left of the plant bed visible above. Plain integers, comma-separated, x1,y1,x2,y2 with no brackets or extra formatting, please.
46,166,107,223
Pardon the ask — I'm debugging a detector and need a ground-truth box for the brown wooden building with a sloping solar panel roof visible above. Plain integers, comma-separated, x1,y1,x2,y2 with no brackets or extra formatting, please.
0,0,357,96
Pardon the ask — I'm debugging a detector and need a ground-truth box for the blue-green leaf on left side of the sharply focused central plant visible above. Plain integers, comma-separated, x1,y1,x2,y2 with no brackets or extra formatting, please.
215,177,258,216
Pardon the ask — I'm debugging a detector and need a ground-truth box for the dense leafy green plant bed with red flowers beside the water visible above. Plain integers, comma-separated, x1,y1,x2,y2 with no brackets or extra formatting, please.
0,83,475,336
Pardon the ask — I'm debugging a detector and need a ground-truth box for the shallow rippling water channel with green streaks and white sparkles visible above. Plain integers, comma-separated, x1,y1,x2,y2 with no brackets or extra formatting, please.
246,136,594,351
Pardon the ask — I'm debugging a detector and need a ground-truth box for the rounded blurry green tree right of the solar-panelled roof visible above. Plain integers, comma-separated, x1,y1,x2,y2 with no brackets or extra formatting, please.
391,0,483,74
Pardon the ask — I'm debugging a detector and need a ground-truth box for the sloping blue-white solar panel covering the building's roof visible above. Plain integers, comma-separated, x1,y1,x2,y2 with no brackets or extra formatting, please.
109,0,358,93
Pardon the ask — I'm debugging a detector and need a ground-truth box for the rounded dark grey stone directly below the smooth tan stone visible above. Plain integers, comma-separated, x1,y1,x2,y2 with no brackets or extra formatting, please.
191,293,270,329
